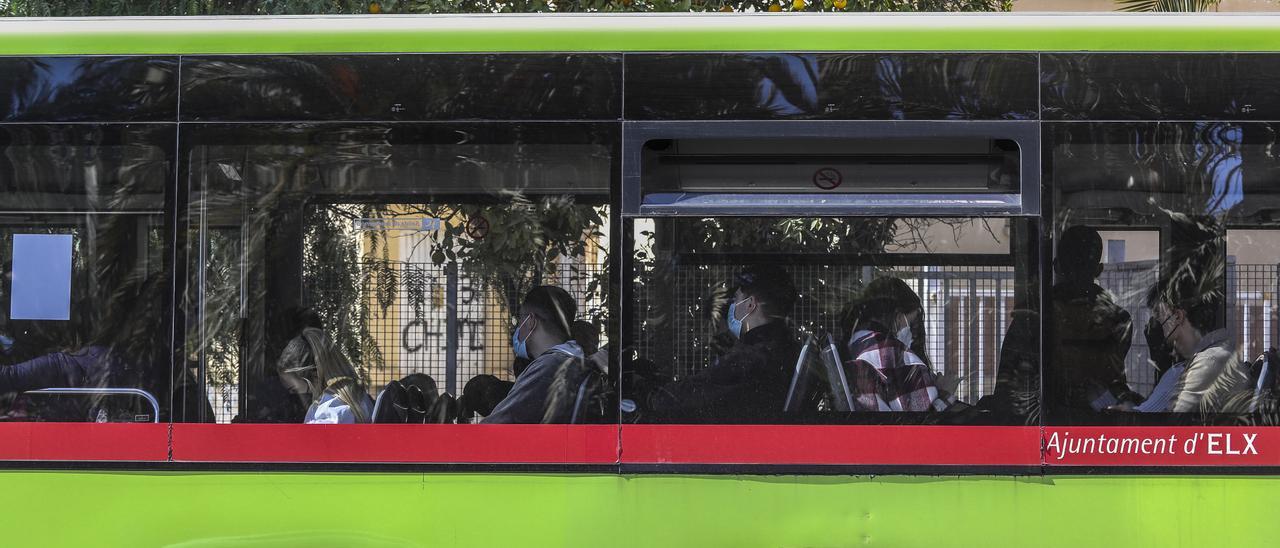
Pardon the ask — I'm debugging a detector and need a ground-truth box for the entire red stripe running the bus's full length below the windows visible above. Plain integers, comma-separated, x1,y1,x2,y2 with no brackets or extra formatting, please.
0,423,1280,467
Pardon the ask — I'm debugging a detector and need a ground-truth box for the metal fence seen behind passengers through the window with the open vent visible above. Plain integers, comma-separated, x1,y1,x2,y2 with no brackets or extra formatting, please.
632,265,1014,401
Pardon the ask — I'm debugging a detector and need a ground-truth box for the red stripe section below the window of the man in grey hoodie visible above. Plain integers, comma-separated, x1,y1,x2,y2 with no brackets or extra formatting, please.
173,424,618,465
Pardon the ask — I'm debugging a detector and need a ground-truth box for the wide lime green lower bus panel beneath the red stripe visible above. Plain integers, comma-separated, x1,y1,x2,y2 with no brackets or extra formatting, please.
0,471,1280,548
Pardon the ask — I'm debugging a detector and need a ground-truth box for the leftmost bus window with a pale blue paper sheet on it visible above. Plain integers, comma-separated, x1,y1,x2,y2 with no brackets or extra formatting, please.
0,124,175,423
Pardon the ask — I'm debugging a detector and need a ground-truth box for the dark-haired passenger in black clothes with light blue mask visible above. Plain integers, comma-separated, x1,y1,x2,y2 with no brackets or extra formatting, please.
636,265,800,423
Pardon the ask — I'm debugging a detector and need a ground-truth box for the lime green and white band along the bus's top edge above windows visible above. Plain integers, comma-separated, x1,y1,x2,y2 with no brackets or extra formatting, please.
0,14,1280,55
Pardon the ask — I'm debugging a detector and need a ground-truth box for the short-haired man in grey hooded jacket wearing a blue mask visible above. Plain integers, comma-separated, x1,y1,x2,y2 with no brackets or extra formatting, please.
483,286,586,424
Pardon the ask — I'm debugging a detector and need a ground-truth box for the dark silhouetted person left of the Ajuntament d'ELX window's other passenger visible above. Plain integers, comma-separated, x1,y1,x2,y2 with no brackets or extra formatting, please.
1046,227,1142,411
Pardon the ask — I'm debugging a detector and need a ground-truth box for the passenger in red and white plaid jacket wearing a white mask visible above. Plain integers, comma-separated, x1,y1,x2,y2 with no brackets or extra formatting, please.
844,277,955,411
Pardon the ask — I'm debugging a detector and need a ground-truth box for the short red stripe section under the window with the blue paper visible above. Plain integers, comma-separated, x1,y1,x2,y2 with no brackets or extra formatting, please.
0,423,169,461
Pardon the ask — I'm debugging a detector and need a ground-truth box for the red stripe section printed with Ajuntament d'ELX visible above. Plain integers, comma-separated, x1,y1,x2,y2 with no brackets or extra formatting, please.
1044,426,1280,466
